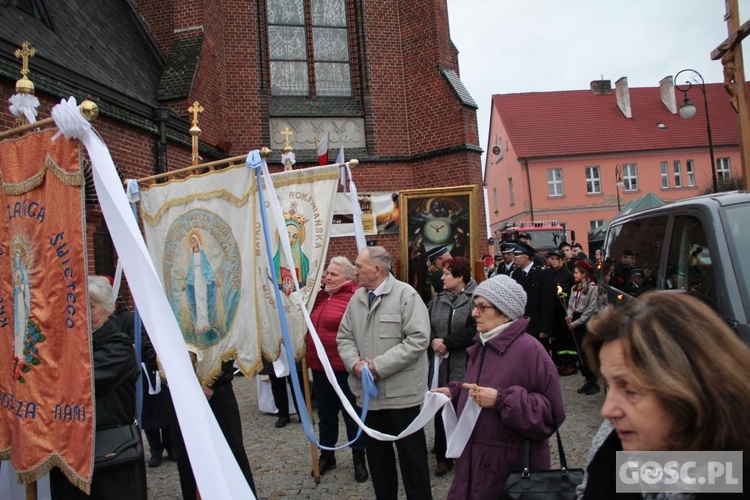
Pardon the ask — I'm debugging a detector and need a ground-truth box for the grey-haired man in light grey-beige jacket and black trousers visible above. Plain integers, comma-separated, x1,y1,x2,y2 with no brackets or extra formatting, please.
337,247,432,499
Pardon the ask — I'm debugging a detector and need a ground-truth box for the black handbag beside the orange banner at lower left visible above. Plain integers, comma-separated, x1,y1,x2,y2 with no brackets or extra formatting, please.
94,424,143,472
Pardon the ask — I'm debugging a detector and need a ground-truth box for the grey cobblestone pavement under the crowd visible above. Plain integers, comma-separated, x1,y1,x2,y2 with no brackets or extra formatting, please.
144,375,604,500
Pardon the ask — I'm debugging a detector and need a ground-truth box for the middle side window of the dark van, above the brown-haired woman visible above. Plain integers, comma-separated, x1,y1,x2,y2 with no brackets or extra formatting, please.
664,215,715,299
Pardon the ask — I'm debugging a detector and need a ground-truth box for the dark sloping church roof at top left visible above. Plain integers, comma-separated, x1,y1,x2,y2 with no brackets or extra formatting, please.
0,0,164,106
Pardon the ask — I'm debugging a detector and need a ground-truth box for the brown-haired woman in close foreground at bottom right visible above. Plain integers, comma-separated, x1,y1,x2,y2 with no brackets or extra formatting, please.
583,291,750,499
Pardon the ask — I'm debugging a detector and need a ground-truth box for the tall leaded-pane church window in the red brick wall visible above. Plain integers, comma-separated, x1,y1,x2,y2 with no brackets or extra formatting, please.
267,0,352,97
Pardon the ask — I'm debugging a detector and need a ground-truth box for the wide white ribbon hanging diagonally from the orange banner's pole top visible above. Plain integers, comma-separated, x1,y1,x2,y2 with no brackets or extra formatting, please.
52,97,256,500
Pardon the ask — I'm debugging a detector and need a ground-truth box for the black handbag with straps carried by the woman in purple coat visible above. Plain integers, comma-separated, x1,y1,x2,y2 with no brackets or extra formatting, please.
503,409,583,500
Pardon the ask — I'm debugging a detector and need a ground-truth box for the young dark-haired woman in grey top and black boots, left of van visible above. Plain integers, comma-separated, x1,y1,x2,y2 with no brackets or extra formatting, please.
565,259,600,396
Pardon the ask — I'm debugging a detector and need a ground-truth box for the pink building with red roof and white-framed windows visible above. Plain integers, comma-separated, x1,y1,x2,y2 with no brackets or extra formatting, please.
485,76,742,256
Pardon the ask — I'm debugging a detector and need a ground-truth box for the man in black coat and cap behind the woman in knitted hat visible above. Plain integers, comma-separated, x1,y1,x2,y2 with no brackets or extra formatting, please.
511,243,557,349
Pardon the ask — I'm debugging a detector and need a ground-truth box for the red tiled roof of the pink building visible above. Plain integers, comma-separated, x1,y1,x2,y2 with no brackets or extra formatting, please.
492,83,750,158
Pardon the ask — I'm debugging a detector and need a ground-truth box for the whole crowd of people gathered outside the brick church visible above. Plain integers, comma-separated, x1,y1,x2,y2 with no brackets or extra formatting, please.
51,239,750,499
